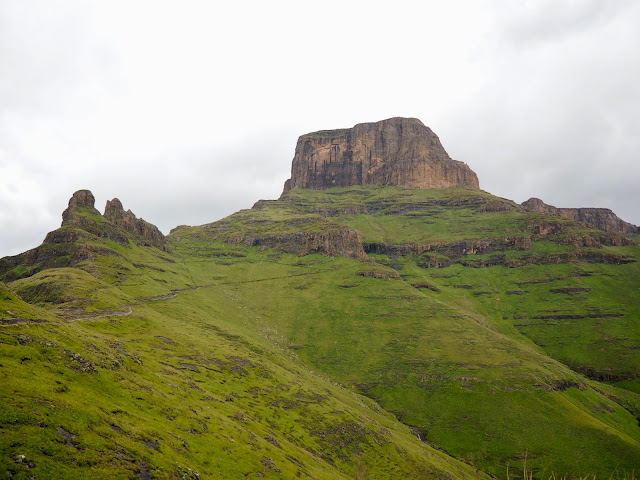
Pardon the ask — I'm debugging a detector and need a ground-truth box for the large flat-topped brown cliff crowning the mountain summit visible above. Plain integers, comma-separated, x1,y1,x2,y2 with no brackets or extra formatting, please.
284,118,479,193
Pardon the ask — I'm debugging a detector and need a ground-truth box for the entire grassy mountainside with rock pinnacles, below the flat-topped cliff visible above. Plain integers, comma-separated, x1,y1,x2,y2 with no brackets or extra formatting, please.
0,119,640,479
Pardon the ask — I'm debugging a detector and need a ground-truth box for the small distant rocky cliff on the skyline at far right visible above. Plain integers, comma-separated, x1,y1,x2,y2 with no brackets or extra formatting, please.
522,198,640,235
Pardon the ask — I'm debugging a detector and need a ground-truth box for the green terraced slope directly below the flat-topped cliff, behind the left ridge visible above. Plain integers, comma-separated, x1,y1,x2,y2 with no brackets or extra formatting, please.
168,186,640,478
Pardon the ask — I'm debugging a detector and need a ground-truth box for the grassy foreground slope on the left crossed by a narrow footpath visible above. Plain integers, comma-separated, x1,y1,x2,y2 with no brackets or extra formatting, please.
0,193,481,479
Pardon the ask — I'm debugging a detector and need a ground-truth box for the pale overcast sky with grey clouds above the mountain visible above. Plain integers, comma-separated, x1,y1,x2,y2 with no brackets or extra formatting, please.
0,0,640,257
